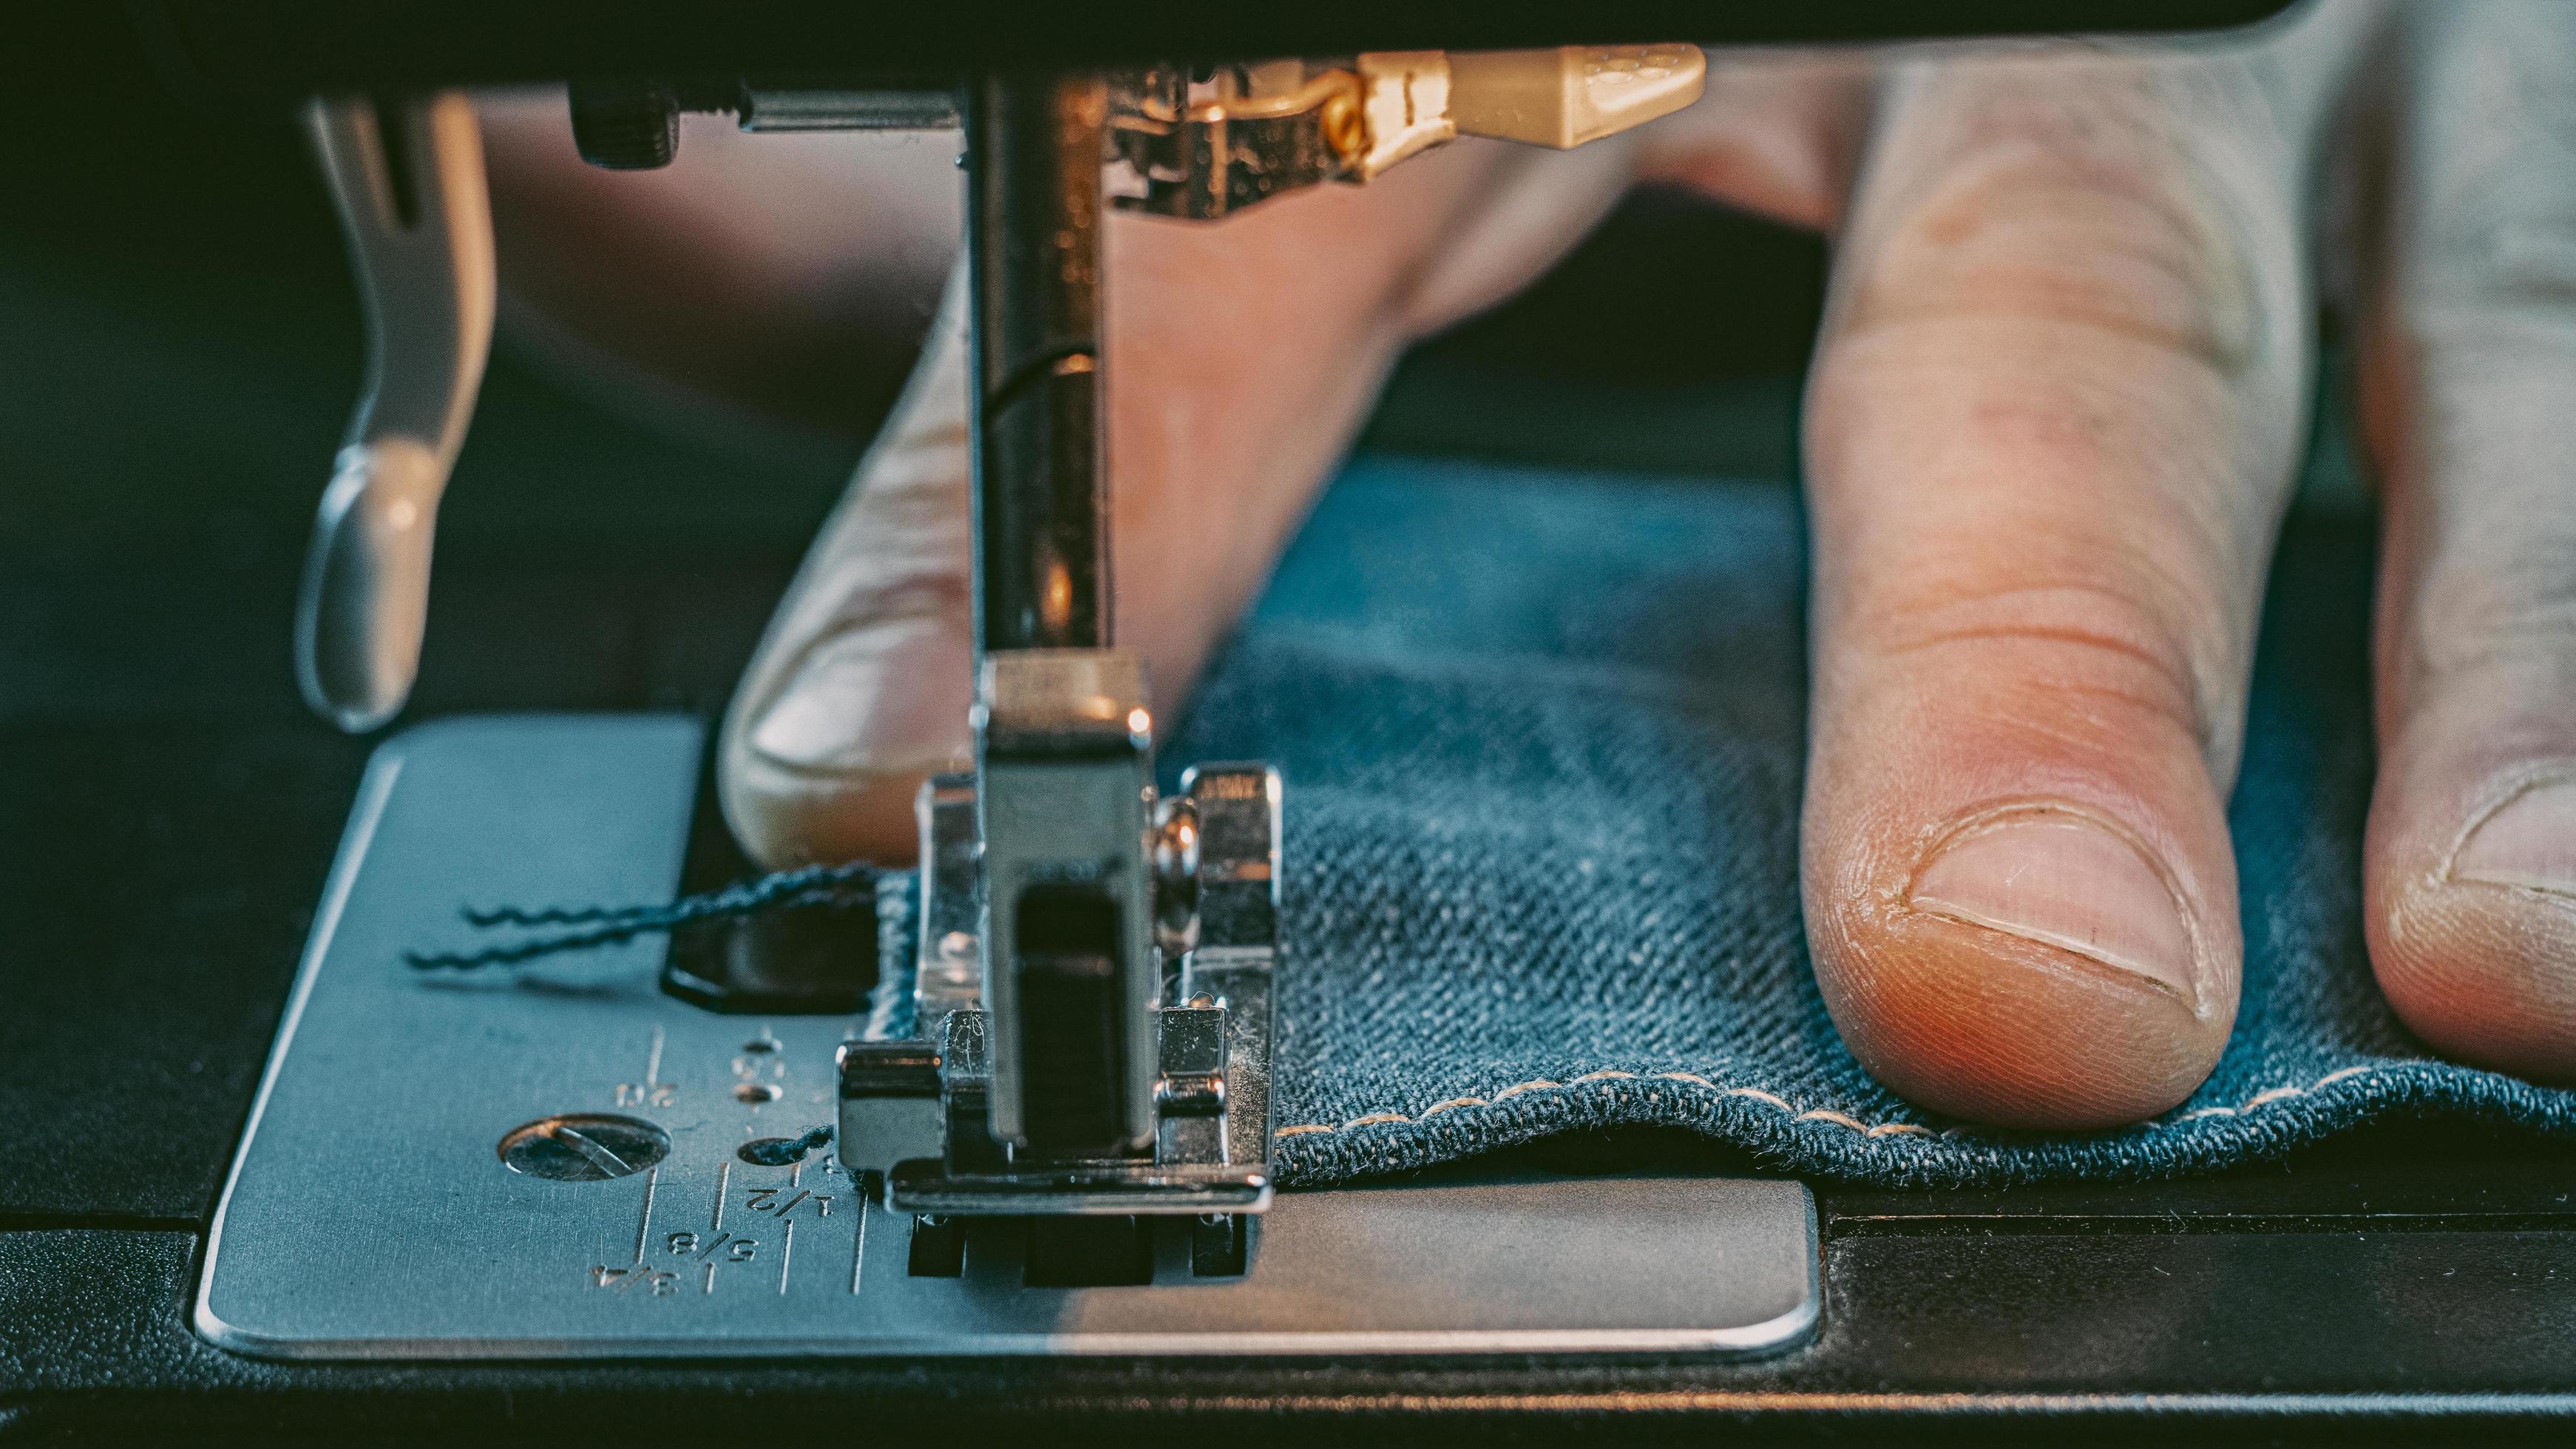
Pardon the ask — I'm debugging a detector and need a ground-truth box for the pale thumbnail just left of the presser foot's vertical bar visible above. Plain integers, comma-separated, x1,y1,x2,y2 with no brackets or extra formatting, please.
750,618,969,770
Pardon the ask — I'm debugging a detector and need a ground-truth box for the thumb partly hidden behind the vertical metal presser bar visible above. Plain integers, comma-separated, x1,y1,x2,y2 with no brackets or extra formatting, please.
719,141,1628,867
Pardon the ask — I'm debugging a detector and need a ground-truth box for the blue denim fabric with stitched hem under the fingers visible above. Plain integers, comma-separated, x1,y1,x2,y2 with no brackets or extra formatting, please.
886,458,2576,1184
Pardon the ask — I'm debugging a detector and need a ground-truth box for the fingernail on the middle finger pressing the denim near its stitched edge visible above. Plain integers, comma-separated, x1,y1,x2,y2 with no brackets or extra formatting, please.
1911,808,2200,1011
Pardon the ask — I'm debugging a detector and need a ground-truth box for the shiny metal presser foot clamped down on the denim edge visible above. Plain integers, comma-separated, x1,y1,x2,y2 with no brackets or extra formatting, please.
840,651,1281,1235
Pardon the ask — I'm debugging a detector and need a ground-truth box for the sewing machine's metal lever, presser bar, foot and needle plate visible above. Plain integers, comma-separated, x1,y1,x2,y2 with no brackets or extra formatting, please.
216,44,1819,1359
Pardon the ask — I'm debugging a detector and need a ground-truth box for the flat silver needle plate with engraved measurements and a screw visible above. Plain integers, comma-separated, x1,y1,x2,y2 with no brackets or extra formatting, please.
196,716,1819,1359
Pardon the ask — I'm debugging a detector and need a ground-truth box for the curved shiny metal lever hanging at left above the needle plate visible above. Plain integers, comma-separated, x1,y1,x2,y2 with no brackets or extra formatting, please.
296,90,495,731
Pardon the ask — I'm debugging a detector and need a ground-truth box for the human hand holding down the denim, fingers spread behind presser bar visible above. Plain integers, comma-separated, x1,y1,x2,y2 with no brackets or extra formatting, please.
700,0,2576,1127
